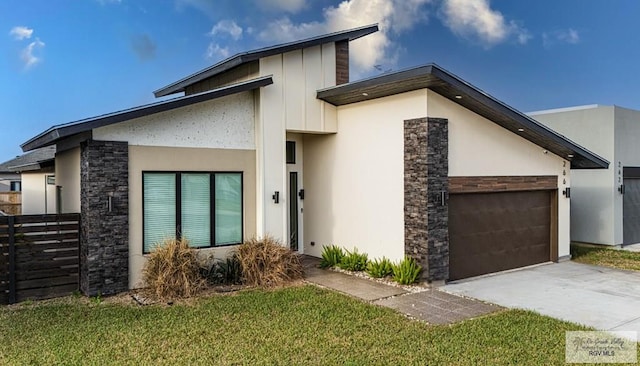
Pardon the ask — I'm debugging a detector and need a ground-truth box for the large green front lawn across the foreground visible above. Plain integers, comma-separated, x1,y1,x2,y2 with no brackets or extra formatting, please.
0,286,585,365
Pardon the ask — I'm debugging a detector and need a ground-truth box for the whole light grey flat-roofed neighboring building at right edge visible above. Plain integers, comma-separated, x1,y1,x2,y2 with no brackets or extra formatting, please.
530,105,640,245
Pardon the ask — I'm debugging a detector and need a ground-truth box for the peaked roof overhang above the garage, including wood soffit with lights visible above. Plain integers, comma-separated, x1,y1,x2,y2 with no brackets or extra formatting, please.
317,64,609,169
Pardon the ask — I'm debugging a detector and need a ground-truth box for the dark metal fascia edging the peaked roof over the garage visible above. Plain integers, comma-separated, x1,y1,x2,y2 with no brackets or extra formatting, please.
316,63,609,169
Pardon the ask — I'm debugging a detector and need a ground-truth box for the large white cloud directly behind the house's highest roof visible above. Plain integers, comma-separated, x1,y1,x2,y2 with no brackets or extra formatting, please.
257,0,431,76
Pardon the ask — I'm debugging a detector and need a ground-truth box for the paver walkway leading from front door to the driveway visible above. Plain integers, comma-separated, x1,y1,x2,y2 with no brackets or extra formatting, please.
303,256,500,324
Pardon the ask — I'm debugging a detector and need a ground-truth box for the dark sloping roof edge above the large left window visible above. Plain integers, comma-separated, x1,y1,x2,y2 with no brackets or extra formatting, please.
20,75,273,152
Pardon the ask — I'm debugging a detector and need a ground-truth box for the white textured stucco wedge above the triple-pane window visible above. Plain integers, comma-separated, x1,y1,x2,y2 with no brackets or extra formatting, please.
93,91,255,149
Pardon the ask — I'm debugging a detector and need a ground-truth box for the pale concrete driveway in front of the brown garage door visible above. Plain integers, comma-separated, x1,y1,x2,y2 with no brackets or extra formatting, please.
440,262,640,332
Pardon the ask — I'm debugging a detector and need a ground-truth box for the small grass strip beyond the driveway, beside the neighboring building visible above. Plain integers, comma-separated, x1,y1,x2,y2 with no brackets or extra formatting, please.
571,244,640,271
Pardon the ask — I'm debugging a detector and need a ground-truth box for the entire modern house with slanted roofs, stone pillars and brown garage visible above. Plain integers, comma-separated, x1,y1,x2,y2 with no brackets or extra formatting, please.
22,25,608,295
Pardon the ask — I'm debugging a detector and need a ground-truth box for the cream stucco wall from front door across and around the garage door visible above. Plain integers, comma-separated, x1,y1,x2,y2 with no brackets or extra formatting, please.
304,90,570,260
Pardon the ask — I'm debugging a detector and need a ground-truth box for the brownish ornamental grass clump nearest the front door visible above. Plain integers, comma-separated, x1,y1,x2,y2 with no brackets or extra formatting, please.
238,236,303,286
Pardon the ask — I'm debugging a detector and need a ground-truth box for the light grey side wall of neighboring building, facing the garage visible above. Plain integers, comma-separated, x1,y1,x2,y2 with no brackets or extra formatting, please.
531,106,616,245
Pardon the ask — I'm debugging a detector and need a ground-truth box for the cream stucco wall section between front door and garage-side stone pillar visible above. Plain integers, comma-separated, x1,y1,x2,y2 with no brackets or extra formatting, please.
304,90,427,261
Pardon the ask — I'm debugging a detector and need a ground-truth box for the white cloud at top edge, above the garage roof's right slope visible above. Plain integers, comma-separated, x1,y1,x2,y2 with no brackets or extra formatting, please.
441,0,532,47
